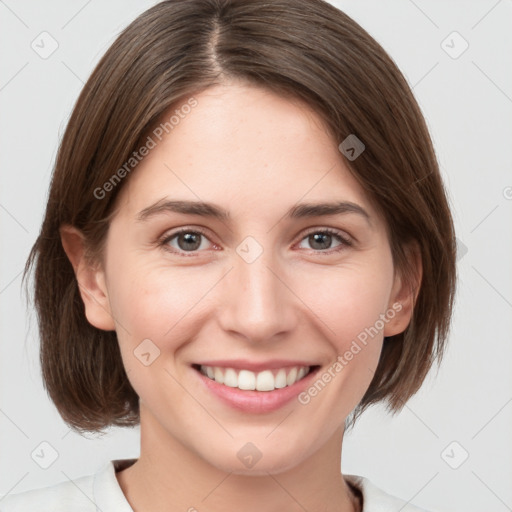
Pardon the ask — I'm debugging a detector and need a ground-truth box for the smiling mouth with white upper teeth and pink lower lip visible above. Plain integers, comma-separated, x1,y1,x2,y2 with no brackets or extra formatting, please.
192,364,321,414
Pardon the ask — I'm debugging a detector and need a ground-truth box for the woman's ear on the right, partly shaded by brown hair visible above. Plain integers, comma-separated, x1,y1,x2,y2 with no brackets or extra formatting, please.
384,242,423,336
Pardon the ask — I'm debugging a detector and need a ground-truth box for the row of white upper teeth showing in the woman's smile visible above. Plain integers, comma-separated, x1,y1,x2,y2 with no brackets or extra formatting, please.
200,366,311,391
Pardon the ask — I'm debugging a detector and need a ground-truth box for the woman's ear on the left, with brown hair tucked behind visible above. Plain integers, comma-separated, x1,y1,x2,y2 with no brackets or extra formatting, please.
60,225,115,331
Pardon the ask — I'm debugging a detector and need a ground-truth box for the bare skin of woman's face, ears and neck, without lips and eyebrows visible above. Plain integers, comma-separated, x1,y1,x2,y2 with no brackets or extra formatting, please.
61,82,420,512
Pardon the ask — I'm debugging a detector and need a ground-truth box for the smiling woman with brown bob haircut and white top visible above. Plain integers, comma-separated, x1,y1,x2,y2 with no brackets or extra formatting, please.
6,0,455,512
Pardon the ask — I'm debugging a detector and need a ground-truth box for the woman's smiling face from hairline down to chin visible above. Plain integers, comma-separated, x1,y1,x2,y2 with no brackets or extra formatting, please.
80,84,409,474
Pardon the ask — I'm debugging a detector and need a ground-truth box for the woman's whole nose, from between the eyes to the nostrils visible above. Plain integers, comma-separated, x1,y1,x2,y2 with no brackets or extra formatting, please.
222,237,292,341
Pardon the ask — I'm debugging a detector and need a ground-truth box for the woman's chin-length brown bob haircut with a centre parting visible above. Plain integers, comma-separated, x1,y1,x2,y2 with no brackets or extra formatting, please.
24,0,456,432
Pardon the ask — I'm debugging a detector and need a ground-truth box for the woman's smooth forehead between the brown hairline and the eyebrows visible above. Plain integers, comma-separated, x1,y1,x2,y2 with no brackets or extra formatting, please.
112,83,371,222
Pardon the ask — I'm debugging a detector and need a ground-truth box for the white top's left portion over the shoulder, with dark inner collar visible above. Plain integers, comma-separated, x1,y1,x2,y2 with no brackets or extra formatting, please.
0,459,134,512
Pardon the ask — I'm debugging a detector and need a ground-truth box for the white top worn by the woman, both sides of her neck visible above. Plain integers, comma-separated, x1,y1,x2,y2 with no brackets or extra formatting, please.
0,459,427,512
